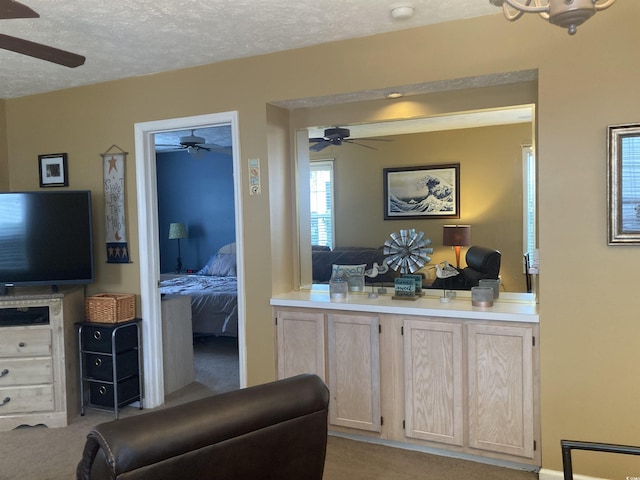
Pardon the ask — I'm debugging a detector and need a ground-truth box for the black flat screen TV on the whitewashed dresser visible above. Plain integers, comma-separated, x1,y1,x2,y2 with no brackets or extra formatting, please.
0,190,94,289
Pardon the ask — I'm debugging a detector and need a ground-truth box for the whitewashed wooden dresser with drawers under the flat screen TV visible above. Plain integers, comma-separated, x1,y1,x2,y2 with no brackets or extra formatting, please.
0,287,85,431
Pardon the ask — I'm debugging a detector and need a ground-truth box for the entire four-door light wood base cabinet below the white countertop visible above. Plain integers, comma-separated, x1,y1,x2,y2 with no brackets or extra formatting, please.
275,307,540,465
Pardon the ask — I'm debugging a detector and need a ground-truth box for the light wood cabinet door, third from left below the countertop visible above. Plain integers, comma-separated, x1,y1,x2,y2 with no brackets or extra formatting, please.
403,320,464,446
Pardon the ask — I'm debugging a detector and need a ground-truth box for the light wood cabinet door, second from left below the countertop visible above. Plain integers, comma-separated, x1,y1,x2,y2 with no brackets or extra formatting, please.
327,314,382,432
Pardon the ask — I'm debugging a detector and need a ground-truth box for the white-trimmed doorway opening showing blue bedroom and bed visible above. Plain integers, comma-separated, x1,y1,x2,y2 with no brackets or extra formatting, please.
154,124,240,400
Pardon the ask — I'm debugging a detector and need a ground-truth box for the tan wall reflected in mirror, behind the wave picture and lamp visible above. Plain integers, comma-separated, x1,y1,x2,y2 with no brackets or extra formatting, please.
311,123,532,292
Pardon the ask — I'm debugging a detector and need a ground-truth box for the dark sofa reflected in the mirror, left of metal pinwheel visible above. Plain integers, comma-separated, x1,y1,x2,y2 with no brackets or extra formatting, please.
311,247,400,284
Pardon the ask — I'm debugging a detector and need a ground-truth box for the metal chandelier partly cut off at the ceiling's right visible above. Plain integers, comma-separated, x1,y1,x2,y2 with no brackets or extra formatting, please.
489,0,616,35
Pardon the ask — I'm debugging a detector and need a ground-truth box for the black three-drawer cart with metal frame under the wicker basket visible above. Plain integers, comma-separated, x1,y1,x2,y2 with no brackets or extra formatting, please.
78,318,142,418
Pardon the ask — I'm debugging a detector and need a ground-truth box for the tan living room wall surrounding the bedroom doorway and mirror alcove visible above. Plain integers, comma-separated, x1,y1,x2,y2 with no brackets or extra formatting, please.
0,1,640,478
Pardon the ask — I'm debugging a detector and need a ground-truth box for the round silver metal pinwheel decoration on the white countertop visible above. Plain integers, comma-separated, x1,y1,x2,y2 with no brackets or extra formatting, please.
383,228,433,273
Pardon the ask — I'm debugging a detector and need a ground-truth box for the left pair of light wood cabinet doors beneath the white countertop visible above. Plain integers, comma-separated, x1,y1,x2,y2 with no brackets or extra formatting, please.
275,308,381,432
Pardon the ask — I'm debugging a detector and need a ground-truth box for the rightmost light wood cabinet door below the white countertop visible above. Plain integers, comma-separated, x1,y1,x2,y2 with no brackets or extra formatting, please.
467,324,534,458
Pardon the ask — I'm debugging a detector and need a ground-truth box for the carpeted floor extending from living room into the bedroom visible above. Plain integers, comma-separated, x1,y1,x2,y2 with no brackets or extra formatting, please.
0,337,538,480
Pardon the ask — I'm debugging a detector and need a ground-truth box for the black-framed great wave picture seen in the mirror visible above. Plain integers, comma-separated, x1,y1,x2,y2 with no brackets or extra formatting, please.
383,163,460,220
